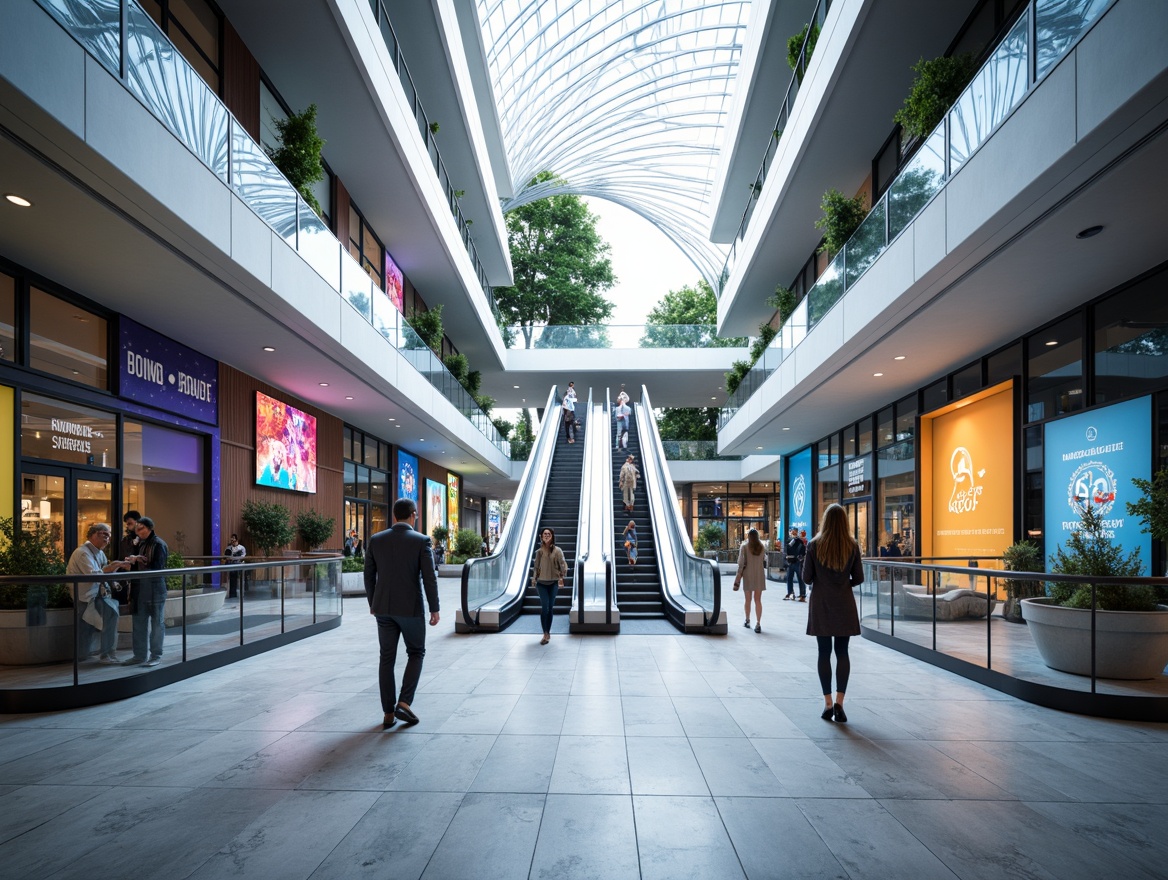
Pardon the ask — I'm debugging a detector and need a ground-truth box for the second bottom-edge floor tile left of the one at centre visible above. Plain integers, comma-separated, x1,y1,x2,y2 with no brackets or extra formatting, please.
311,791,463,880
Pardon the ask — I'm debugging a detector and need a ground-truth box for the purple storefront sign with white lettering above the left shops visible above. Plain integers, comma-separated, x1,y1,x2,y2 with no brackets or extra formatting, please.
118,317,218,424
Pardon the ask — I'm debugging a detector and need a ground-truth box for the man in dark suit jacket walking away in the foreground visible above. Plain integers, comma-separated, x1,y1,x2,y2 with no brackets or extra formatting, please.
364,498,438,728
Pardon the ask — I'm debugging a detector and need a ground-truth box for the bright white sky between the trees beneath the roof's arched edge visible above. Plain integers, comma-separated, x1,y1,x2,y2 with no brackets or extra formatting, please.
584,199,701,324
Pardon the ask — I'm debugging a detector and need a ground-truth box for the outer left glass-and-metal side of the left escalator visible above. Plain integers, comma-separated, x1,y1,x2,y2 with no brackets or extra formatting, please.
454,386,558,632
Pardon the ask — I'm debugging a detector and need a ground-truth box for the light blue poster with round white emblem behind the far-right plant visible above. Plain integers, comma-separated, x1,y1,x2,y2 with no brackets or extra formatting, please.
1043,397,1152,574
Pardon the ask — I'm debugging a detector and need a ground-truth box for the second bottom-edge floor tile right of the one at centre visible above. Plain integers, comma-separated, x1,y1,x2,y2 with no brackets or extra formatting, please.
715,797,862,880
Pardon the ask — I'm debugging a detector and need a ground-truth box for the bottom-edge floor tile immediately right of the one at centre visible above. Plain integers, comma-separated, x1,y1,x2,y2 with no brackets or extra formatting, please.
633,796,745,880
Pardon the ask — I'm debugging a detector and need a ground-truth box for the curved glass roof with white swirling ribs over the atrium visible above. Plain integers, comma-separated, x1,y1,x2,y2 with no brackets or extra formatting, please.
478,0,750,290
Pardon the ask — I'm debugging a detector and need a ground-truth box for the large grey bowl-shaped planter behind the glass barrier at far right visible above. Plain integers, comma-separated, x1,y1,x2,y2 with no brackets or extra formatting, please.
1022,597,1168,680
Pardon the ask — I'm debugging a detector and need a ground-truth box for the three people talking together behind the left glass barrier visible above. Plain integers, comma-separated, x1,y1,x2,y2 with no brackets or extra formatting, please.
65,511,171,666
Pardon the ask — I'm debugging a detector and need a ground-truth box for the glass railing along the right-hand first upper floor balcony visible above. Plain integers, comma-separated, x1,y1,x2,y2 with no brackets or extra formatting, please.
718,0,1114,429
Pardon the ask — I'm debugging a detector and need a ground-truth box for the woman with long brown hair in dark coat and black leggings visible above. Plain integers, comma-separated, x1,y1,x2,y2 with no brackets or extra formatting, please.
804,504,864,722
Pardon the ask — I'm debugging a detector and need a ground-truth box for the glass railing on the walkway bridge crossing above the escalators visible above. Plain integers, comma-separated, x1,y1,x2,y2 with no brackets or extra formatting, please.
503,324,752,349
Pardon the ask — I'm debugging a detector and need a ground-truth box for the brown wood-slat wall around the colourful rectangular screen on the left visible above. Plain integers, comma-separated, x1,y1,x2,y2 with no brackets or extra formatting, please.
220,363,345,552
